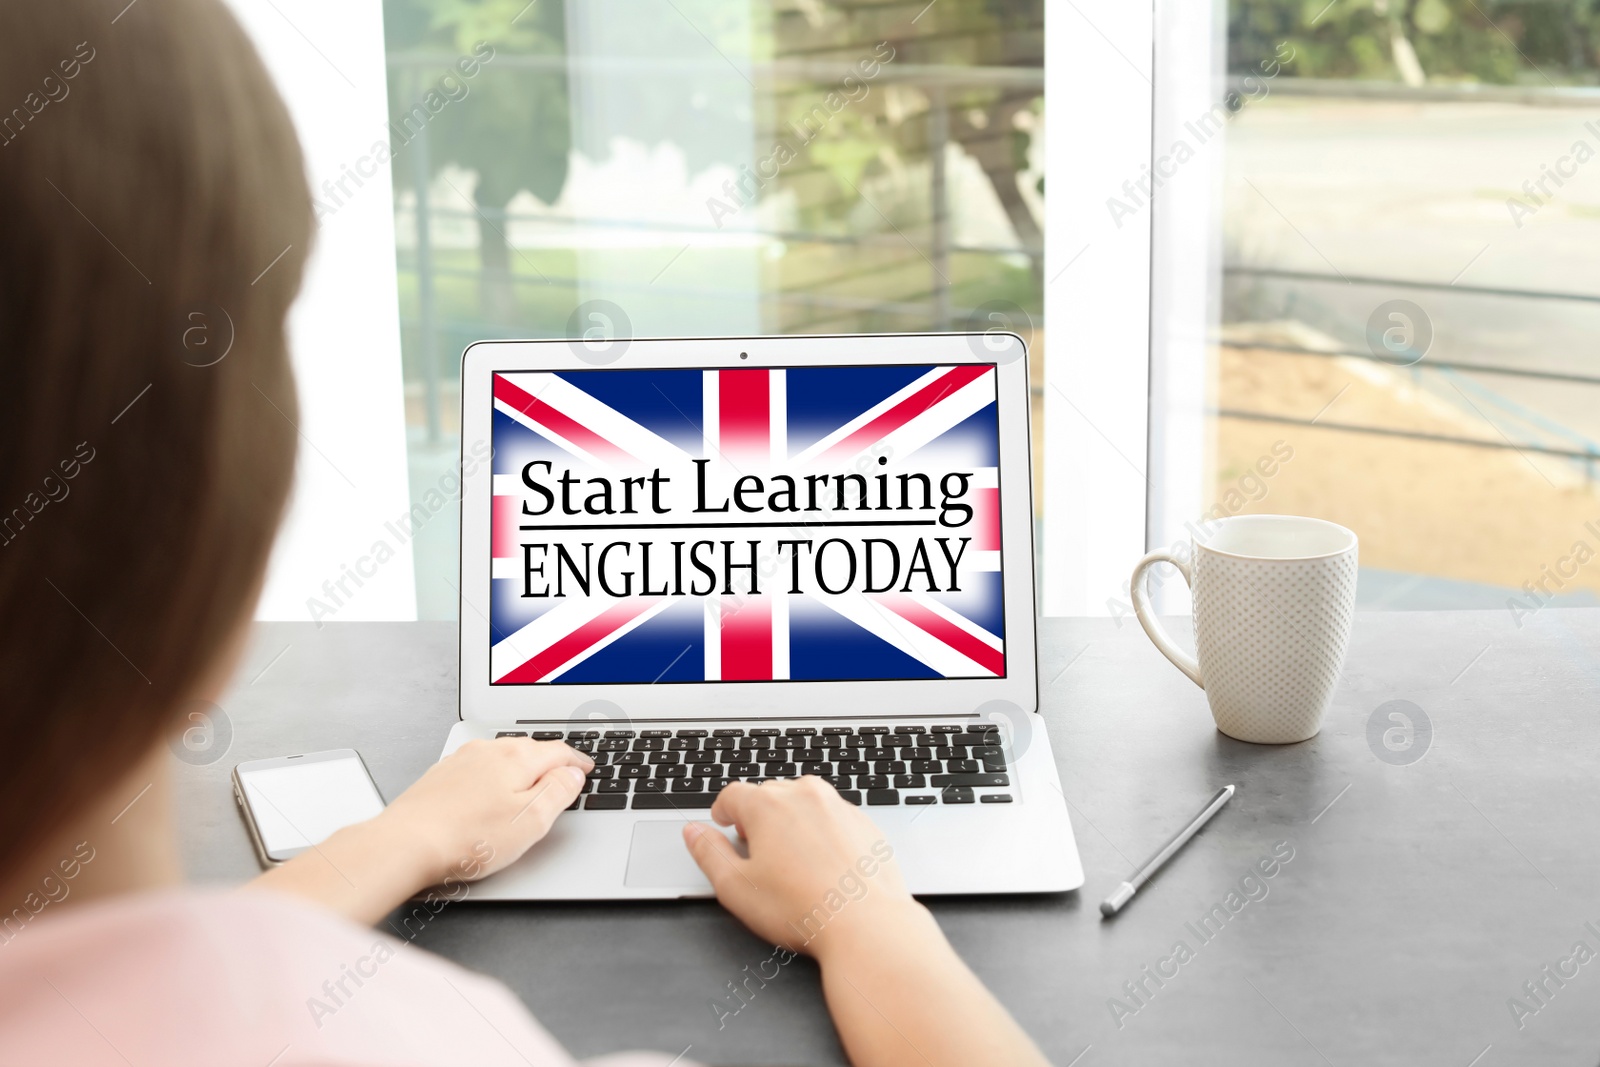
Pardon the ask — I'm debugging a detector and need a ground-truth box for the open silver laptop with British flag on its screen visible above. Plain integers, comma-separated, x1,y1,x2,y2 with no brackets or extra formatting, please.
445,333,1083,901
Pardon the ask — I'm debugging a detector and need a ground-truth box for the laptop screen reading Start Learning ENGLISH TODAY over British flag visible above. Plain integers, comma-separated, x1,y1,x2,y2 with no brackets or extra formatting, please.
490,363,1006,686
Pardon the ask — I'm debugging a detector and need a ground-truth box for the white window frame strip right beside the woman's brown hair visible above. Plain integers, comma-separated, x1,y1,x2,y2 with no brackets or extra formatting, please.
229,0,425,622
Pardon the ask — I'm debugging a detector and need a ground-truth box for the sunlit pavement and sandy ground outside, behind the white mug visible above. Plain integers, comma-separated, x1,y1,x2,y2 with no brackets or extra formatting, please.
1211,96,1600,611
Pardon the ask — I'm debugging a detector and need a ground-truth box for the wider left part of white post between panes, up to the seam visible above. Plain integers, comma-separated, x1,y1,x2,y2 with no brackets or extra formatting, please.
1042,0,1155,616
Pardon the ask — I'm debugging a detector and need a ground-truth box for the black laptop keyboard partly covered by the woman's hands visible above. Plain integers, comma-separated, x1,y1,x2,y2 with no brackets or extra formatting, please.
496,723,1011,811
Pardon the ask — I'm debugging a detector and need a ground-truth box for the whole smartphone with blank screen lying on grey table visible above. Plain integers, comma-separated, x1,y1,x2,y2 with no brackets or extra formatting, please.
234,749,384,867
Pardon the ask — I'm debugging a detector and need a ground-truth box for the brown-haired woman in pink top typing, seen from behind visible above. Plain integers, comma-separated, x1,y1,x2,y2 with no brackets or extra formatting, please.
0,0,1043,1067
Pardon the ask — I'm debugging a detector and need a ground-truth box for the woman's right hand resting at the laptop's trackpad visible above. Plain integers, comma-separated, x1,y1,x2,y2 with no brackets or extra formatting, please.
683,776,938,958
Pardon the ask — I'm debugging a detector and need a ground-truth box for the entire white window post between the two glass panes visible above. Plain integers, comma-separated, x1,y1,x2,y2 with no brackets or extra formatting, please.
1042,0,1226,621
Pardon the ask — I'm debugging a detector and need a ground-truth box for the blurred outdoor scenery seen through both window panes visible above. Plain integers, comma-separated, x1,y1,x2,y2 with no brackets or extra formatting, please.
384,0,1600,619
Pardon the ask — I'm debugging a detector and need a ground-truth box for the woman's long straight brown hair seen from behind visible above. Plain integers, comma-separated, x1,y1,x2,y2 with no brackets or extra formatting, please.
0,0,314,873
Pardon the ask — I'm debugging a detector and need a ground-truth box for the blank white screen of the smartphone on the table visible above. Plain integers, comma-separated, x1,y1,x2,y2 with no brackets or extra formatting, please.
240,757,384,856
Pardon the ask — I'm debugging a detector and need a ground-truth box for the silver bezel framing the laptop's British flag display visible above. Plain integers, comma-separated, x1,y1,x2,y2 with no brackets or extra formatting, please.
458,333,1038,725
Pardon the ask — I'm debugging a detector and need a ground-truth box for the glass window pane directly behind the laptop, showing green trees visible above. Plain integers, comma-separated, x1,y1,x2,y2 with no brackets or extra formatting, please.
384,0,1045,619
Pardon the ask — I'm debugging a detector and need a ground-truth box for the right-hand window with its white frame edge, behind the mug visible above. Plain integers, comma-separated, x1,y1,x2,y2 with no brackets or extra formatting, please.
1130,0,1600,624
